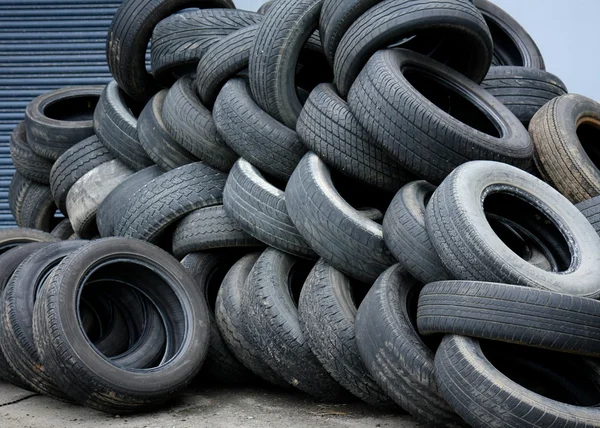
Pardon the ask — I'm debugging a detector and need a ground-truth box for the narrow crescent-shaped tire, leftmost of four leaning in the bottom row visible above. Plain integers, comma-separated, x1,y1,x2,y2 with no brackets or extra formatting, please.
215,253,289,387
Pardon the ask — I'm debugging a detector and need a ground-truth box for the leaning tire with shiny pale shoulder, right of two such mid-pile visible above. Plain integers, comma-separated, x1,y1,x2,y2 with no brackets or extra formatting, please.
285,152,395,283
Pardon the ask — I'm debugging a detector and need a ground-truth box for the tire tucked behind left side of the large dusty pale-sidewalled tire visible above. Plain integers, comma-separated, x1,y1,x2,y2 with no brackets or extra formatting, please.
383,181,452,284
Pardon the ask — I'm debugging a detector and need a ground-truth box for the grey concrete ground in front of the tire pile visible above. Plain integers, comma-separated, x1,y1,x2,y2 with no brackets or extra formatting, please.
0,383,419,428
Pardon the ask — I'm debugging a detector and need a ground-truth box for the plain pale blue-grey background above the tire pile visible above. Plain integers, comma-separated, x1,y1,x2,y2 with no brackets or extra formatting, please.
234,0,600,102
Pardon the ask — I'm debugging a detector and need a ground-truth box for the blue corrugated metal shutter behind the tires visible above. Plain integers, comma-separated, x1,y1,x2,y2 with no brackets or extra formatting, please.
0,0,121,227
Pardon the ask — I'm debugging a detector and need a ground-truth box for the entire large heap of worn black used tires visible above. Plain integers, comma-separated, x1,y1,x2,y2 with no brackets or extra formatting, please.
0,0,600,427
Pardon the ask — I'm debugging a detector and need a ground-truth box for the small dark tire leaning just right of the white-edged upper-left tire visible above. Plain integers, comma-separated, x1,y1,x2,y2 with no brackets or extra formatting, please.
137,89,198,171
